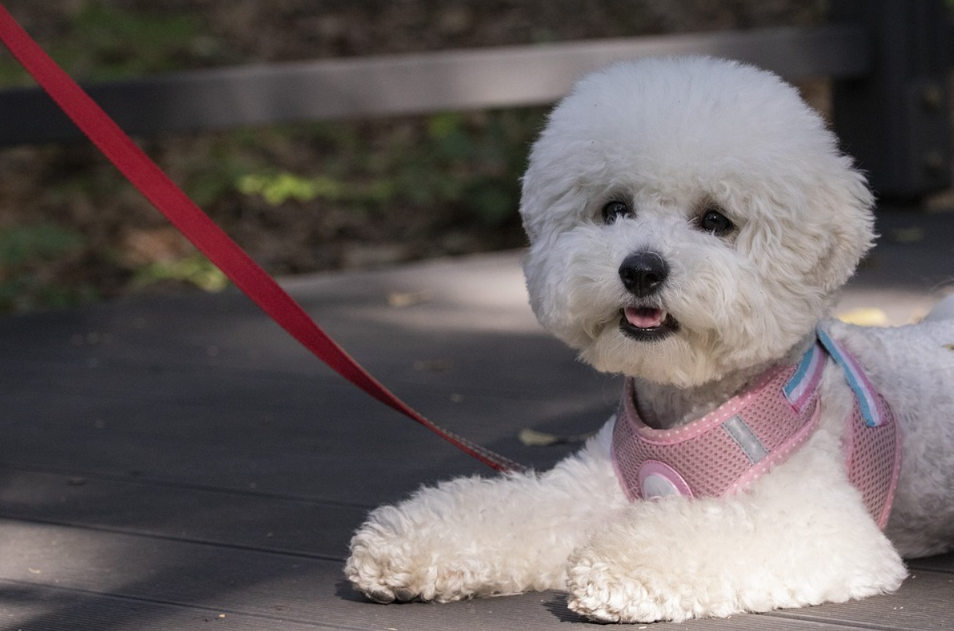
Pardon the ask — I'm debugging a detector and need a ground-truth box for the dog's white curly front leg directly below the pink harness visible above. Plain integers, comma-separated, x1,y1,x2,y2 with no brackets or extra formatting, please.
567,460,906,622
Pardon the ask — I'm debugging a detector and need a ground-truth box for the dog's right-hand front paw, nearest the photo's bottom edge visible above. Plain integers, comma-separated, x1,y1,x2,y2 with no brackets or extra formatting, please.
567,552,695,622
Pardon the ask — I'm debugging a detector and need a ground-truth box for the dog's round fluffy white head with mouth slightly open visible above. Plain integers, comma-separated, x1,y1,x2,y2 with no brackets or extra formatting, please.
520,57,873,387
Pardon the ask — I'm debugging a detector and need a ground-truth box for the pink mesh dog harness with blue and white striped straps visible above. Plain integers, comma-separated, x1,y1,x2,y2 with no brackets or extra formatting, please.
612,330,901,528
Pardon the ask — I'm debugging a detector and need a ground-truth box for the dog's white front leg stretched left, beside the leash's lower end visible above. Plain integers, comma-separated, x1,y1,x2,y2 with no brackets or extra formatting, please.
345,431,627,602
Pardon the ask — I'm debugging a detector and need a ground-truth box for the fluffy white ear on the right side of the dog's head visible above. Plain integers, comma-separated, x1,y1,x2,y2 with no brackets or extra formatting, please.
811,156,875,293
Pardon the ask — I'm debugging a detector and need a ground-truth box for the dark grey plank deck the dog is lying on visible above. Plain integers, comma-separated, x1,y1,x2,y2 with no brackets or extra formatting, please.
0,213,954,631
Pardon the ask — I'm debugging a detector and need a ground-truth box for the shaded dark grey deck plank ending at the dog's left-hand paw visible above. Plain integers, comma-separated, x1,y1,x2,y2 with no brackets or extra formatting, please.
0,470,367,561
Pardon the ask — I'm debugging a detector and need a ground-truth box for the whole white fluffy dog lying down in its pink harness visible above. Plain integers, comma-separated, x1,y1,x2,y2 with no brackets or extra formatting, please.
345,57,954,622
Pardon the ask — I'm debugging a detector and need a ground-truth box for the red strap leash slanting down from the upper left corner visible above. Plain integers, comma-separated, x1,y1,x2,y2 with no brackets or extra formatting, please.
0,4,524,471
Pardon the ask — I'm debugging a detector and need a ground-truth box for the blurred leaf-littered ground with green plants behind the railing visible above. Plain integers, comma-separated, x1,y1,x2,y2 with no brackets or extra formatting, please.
0,0,825,311
